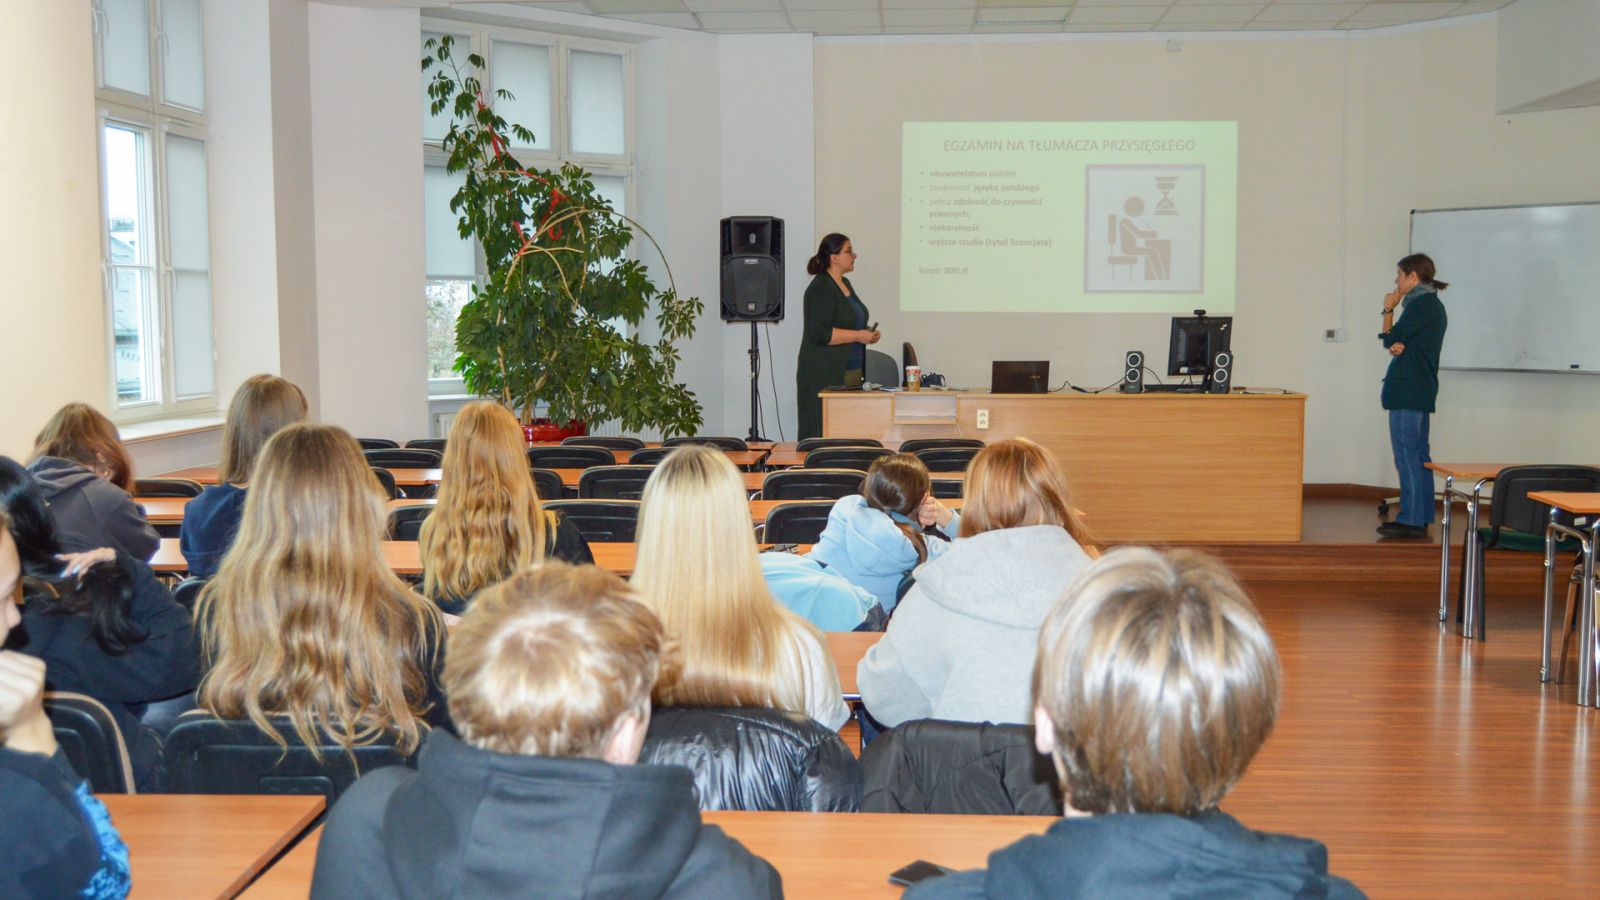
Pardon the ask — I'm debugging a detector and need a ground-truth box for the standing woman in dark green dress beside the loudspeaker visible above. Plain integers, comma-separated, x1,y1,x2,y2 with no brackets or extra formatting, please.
795,234,880,440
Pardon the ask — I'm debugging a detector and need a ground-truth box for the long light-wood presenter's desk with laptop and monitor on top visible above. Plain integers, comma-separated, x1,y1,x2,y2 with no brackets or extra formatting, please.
822,391,1306,543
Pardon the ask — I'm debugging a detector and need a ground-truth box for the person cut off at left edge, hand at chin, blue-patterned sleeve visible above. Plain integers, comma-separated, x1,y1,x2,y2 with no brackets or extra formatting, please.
0,511,128,898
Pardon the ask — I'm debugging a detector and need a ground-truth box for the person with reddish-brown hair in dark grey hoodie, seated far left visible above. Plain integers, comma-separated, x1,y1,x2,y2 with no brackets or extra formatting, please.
27,404,162,560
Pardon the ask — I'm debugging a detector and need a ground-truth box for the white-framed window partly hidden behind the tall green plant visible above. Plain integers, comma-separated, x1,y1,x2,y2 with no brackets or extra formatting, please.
421,21,634,394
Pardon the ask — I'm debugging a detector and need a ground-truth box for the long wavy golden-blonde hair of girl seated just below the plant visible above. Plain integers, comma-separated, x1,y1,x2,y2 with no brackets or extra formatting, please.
418,400,555,599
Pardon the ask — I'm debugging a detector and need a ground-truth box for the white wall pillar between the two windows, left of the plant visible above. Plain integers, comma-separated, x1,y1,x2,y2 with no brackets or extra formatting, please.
302,3,429,440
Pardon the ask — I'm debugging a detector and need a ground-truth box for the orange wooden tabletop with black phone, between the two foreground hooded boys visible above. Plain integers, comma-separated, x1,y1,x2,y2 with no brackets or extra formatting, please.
245,812,1056,900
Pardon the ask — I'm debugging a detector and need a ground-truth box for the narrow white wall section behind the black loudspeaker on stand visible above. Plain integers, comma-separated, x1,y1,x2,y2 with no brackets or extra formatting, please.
709,34,812,440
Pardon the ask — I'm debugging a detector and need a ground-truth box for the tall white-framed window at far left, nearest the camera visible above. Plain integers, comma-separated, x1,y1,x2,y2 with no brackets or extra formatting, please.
90,0,216,420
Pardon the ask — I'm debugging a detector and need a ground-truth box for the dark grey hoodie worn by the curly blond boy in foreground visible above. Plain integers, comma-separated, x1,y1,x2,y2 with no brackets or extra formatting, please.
310,732,782,900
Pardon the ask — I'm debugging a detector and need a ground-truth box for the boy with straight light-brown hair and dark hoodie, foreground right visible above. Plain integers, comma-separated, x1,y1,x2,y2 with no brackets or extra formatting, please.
906,548,1362,900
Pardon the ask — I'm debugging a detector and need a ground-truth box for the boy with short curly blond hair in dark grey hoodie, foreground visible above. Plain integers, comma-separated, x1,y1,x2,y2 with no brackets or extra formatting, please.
312,562,782,900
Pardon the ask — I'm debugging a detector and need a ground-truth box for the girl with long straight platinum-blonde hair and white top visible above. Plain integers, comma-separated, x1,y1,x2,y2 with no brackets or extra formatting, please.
632,445,832,713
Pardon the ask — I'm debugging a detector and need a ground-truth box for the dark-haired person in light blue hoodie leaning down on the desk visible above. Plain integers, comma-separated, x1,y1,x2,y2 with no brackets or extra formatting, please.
810,453,962,612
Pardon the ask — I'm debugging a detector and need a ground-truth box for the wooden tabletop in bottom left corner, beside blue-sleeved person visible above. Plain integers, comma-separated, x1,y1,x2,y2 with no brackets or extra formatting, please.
99,794,323,898
